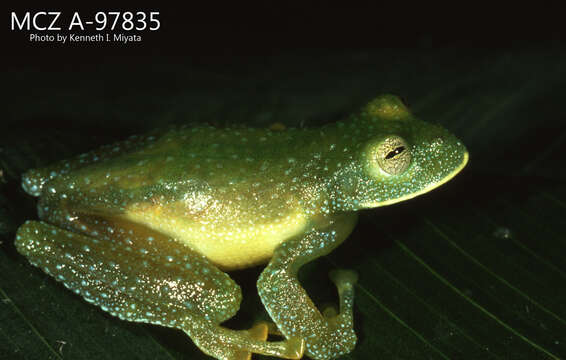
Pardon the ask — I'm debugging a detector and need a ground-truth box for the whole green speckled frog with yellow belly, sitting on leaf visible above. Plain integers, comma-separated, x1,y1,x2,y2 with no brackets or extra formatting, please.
15,95,469,360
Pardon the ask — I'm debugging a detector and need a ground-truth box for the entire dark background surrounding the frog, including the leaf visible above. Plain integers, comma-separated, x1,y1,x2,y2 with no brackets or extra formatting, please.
0,2,566,359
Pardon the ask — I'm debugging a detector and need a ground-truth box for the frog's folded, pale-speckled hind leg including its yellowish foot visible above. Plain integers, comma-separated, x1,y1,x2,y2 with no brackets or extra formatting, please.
16,221,304,360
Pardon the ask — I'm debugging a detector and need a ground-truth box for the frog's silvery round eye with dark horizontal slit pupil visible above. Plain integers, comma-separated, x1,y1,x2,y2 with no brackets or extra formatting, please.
375,136,411,175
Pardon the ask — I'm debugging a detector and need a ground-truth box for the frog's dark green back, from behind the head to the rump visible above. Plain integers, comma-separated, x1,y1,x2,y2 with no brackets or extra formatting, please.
22,125,338,196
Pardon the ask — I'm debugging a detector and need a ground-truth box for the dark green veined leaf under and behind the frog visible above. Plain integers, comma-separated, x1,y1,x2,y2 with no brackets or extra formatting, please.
0,50,566,359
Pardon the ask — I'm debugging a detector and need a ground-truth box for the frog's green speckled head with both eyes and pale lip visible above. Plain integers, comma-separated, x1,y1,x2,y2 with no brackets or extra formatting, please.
330,95,468,209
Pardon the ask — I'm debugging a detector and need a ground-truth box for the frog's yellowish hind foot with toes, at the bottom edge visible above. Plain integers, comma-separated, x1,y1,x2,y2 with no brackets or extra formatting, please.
183,318,305,360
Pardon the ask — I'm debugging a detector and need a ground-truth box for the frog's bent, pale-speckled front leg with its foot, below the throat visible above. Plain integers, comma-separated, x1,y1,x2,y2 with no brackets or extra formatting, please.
258,214,357,359
